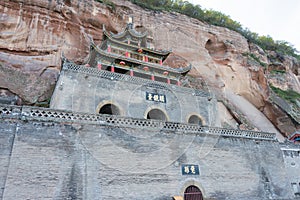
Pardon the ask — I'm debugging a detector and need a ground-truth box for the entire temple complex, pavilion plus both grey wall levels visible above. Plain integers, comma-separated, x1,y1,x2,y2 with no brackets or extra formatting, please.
0,18,290,200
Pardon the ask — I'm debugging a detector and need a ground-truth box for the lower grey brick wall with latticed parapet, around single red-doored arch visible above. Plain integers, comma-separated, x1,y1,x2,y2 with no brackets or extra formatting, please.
0,106,299,200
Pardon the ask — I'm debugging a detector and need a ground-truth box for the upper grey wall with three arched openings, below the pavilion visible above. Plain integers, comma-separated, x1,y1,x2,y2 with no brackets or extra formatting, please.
50,64,220,126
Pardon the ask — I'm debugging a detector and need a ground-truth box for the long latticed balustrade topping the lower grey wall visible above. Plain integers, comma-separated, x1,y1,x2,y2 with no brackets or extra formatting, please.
0,105,276,141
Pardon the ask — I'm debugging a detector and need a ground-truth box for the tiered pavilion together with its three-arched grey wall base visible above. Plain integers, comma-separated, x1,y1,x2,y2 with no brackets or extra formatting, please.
50,18,219,126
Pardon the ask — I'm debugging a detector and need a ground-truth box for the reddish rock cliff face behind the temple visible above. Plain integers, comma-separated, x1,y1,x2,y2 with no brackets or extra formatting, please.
0,0,300,138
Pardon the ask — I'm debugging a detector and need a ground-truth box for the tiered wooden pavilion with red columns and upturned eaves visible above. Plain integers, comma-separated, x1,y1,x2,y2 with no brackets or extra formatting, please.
87,19,191,85
